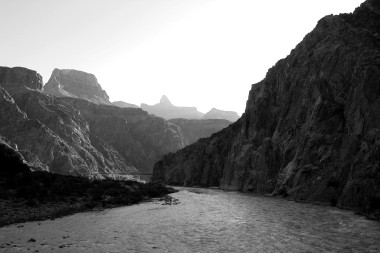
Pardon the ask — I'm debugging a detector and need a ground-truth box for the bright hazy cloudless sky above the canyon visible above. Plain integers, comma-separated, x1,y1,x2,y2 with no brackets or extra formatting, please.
0,0,364,114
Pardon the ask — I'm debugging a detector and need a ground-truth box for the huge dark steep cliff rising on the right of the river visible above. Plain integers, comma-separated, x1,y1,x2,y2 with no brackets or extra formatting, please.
153,0,380,217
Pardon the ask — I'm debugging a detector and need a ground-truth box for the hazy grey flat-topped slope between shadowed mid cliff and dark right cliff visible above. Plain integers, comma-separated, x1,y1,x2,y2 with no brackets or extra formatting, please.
169,119,231,146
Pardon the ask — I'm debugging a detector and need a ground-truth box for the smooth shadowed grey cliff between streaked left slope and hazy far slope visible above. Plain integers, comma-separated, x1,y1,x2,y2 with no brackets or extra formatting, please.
58,98,184,173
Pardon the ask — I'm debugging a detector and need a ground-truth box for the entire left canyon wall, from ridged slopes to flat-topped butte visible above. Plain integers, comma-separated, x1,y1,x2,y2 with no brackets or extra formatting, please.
0,67,230,178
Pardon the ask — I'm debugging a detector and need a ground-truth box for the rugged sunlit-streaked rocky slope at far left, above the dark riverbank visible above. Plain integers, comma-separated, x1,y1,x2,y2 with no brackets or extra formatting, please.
0,67,136,177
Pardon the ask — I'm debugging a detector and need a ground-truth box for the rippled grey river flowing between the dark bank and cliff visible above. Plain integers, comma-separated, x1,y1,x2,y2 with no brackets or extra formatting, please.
0,188,380,252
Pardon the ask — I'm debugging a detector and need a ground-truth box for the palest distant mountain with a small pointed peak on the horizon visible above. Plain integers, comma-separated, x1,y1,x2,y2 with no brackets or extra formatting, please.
141,95,203,119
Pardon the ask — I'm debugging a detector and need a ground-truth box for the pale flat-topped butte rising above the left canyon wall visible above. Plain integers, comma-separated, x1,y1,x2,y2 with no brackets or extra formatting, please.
44,69,111,105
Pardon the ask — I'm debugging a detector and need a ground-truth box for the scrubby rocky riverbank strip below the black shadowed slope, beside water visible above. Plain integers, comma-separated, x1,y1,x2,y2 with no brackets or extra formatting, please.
0,180,176,227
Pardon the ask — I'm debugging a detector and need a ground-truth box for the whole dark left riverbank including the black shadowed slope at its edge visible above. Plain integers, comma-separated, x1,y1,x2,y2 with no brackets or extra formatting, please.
0,139,176,227
